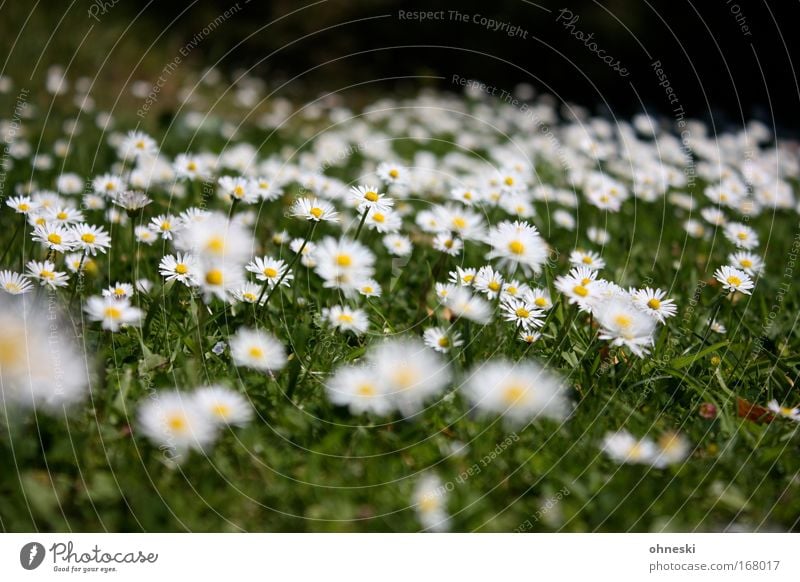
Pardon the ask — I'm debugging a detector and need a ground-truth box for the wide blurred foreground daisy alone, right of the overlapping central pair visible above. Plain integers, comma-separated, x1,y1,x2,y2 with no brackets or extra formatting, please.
463,359,569,425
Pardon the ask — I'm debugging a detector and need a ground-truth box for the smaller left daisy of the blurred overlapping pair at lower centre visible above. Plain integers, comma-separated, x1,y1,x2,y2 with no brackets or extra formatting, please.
325,365,394,416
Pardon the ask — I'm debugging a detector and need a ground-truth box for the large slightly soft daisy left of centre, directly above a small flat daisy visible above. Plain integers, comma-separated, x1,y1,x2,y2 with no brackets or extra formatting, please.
313,237,375,293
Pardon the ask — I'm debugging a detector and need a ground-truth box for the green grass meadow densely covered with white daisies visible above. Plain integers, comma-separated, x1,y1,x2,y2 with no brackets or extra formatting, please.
0,69,800,532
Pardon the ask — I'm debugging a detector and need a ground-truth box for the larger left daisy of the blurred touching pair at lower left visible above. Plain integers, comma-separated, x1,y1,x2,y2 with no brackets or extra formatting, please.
138,390,217,461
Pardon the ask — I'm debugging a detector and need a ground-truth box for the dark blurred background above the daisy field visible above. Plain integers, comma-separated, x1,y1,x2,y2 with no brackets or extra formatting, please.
0,0,800,129
